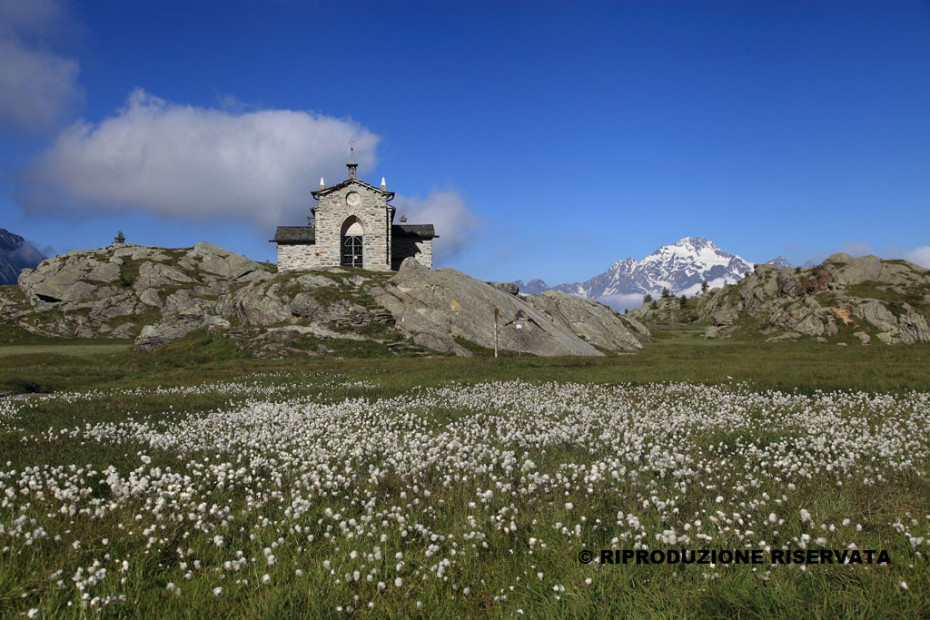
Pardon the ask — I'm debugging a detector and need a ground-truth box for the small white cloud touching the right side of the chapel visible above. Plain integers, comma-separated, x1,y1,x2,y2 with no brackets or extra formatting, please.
394,191,480,263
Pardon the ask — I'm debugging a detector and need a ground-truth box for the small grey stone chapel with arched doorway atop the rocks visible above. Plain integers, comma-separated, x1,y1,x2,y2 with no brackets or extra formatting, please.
271,151,439,271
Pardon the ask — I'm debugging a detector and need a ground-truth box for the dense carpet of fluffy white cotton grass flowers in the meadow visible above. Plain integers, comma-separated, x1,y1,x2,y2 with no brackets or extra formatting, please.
0,373,930,614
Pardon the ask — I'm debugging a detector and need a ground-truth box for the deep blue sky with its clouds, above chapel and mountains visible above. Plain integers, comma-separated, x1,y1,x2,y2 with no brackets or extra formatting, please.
0,0,930,284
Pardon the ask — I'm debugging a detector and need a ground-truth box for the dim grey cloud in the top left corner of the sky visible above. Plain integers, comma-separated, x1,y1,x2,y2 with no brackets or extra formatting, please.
0,0,82,131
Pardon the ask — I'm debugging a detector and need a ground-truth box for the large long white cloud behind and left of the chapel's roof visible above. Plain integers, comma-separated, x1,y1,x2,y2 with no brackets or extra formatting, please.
19,89,379,228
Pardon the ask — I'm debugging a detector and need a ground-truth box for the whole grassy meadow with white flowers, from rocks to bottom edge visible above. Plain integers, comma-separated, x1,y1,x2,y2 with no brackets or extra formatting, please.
0,331,930,618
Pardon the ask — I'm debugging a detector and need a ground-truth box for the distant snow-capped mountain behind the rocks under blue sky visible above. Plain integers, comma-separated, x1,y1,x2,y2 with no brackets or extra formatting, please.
514,237,753,310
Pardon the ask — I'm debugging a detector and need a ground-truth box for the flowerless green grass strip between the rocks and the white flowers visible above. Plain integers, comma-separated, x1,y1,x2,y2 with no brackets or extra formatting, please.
0,329,930,392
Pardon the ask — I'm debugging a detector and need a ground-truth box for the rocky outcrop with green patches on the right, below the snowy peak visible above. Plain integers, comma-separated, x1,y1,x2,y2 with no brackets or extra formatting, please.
631,254,930,345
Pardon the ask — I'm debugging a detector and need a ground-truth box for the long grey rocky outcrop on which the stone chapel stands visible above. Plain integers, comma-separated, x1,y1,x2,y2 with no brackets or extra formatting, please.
0,243,649,355
